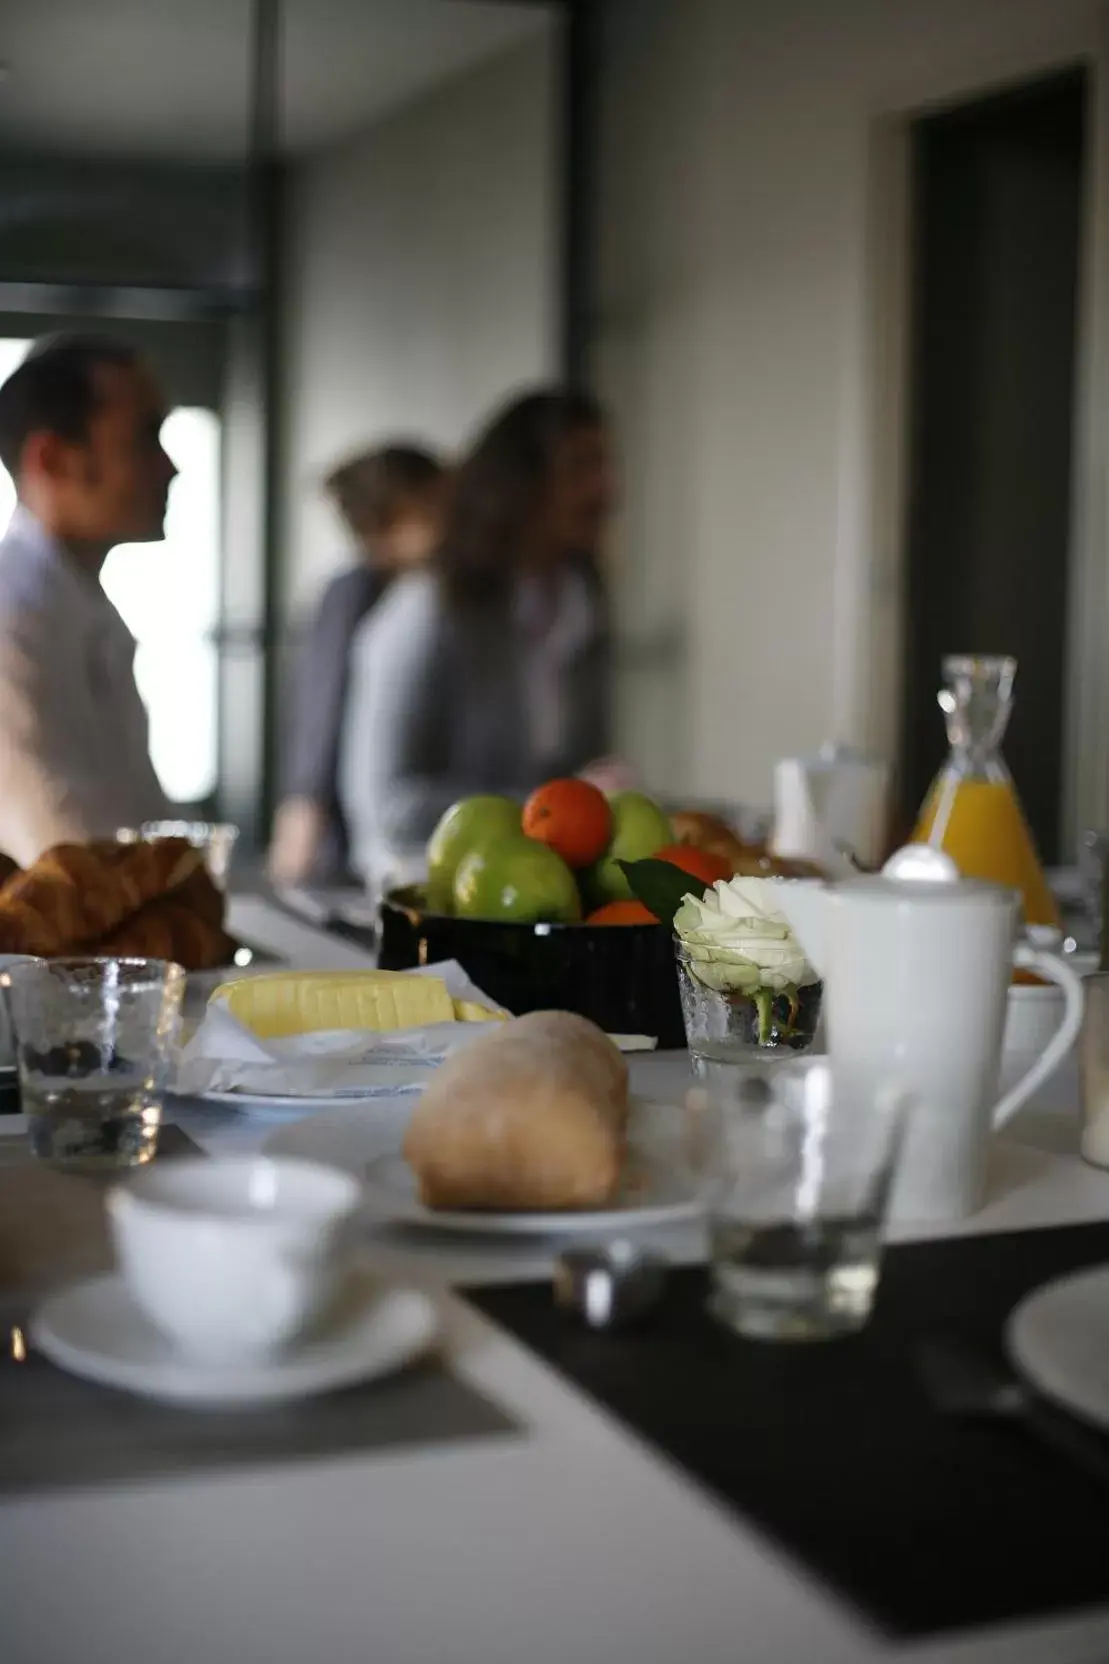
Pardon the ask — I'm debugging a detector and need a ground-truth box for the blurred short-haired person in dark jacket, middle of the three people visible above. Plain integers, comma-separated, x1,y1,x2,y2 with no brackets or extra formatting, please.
268,444,446,884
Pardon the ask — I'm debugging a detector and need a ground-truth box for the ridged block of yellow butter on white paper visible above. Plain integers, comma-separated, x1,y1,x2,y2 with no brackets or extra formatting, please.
211,970,456,1040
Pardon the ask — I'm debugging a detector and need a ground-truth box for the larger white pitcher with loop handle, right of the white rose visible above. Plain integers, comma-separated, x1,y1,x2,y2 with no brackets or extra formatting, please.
779,879,1082,1220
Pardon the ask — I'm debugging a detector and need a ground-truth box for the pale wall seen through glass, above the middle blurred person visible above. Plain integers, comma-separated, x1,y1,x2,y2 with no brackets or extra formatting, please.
276,30,558,612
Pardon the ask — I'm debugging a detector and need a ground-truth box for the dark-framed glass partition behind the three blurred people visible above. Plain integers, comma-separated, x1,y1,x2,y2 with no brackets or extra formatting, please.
0,0,563,847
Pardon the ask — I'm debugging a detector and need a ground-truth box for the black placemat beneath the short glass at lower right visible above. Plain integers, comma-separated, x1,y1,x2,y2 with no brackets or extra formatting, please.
468,1225,1109,1637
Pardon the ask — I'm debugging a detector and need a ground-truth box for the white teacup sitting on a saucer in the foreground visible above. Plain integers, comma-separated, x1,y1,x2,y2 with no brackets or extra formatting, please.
107,1156,361,1363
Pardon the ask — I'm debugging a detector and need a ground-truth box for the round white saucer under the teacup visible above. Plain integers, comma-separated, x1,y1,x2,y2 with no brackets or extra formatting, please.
32,1271,438,1406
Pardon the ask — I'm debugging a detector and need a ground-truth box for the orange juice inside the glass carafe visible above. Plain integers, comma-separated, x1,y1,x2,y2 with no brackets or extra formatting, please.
913,769,1059,925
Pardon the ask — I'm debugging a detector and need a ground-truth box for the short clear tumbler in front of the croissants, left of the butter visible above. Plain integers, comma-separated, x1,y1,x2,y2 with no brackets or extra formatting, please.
0,958,185,1168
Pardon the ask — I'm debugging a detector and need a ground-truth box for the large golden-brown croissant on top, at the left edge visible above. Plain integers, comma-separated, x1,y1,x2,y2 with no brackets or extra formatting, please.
0,839,203,957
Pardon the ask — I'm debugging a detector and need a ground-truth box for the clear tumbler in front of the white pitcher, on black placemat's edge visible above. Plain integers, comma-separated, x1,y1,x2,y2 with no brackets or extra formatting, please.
686,1057,911,1341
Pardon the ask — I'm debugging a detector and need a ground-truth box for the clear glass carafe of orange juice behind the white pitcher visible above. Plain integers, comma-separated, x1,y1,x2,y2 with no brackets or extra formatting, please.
913,654,1059,925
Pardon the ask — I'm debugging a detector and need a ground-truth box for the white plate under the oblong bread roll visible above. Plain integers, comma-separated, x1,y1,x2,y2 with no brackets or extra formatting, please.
263,1098,701,1236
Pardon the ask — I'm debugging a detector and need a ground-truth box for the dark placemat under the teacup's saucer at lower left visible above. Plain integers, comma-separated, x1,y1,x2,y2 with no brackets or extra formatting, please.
0,1308,518,1498
